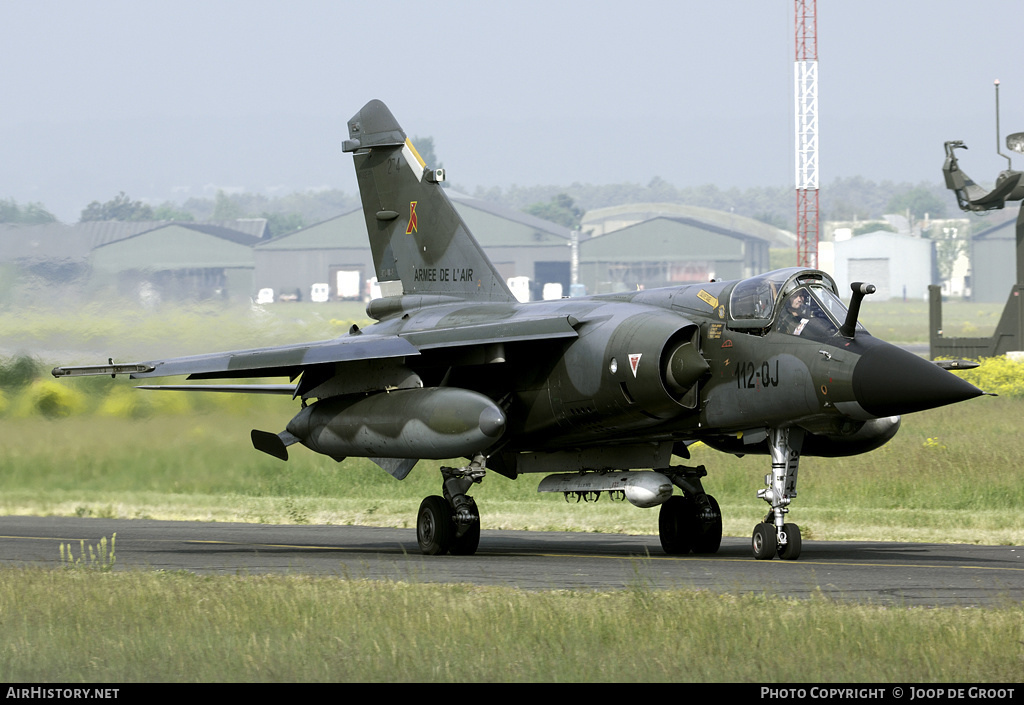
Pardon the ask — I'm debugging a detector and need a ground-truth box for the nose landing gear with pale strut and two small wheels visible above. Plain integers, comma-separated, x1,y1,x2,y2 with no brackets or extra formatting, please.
751,428,804,561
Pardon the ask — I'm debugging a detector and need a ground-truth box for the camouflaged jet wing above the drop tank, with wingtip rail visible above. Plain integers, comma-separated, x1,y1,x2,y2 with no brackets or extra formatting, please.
53,316,578,383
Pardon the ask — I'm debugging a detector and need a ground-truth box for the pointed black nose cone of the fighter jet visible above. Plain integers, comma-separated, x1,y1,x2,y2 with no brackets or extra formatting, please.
853,343,984,417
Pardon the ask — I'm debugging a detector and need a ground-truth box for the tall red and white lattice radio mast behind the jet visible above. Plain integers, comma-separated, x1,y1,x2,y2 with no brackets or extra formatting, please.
795,0,818,268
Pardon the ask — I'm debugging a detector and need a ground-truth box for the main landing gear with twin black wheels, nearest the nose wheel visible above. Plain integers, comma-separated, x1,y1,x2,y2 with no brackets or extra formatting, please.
657,465,722,555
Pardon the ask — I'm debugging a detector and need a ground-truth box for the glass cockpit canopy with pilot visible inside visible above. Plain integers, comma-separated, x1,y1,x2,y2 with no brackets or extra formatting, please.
729,267,864,340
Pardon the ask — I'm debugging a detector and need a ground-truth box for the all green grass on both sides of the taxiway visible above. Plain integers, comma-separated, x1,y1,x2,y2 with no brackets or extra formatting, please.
0,303,1024,683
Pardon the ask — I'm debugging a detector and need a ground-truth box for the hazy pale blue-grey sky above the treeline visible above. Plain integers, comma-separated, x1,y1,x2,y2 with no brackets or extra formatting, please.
0,0,1024,221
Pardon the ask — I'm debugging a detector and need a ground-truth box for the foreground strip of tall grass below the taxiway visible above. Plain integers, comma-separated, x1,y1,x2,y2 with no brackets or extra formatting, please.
0,563,1024,683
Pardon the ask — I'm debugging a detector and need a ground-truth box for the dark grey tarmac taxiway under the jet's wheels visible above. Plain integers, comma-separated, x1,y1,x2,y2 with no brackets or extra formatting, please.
0,516,1024,606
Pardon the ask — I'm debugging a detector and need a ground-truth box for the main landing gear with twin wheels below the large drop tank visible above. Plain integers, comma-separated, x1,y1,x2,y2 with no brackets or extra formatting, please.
416,455,486,555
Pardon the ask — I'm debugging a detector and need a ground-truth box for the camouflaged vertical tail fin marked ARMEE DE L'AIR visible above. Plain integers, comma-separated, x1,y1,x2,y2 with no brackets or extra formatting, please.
343,100,515,301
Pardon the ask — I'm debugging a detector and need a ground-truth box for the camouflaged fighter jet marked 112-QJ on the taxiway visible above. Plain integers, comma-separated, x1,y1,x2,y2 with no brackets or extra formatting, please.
53,100,982,559
